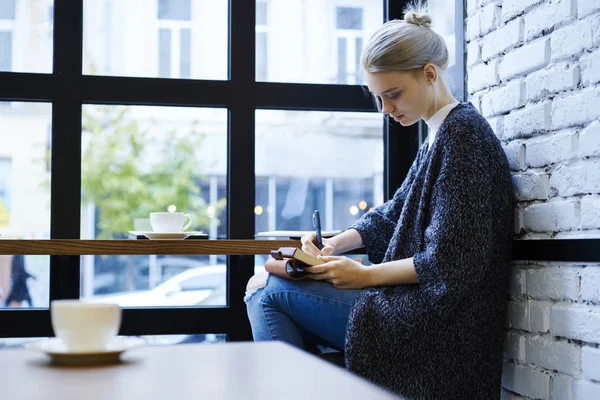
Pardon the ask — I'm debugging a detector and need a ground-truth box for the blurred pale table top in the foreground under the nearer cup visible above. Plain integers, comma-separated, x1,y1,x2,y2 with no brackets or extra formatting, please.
0,342,398,400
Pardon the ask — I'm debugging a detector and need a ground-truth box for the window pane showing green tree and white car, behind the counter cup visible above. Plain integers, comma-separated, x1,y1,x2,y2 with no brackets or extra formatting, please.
81,105,227,306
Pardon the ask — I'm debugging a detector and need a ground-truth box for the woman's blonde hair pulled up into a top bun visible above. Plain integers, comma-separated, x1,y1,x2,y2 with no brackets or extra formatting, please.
361,1,448,79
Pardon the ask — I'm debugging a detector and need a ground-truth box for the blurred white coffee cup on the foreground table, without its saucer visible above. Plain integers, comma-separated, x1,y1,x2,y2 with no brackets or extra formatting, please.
50,300,121,352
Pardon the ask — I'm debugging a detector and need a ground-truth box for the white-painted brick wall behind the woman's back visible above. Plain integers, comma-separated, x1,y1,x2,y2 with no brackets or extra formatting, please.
465,0,600,400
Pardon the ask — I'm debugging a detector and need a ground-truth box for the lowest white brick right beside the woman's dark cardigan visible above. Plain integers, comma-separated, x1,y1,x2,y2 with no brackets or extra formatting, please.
502,361,550,399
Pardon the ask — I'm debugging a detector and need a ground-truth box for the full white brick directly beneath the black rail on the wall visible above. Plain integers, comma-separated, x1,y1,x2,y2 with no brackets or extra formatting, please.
526,267,579,300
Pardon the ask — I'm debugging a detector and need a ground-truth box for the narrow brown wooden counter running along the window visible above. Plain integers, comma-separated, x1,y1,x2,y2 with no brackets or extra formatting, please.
0,239,300,256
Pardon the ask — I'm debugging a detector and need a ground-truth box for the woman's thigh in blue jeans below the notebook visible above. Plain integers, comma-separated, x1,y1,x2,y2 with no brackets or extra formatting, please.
245,275,360,349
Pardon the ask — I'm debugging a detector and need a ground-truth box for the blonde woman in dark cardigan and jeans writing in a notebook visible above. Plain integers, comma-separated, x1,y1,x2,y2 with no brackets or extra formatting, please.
245,7,512,399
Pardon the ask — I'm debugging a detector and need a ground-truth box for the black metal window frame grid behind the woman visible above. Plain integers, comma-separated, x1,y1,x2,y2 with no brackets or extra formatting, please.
0,0,464,341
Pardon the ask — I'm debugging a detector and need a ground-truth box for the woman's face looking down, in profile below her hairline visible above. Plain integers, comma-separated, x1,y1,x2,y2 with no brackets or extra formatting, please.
365,64,435,126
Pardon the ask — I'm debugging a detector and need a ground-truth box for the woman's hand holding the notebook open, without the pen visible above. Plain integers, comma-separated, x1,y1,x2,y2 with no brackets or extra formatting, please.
305,256,371,289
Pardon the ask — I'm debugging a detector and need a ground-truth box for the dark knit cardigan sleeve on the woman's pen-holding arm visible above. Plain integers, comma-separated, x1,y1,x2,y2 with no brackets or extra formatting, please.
350,147,423,263
